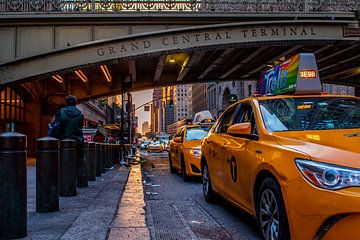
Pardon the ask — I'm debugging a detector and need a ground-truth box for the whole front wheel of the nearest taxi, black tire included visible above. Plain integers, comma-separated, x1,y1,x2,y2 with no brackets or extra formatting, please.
256,177,290,240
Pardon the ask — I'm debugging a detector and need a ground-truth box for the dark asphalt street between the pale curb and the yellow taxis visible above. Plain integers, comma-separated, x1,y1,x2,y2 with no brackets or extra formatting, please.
142,152,260,240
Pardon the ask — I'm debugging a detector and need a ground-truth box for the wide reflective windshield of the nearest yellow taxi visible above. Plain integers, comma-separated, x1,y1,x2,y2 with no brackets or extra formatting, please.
259,97,360,132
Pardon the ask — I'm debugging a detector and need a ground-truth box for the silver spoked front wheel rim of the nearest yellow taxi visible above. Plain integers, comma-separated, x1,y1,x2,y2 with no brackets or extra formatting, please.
259,189,279,240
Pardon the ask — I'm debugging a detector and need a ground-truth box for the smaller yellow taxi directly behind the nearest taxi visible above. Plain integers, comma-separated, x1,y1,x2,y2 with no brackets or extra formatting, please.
169,125,210,181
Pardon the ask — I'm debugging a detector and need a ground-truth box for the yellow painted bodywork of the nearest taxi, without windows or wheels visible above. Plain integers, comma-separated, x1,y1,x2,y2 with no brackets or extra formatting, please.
202,95,360,240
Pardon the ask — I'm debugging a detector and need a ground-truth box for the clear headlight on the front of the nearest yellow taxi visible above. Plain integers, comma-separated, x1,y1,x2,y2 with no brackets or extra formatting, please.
295,159,360,190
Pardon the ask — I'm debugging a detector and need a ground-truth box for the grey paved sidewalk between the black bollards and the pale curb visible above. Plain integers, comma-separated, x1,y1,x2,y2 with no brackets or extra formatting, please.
24,166,130,240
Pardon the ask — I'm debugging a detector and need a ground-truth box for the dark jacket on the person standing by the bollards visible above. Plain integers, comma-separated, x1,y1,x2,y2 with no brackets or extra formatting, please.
59,106,84,143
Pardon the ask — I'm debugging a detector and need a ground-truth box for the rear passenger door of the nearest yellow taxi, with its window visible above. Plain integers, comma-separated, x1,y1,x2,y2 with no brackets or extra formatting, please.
206,107,236,194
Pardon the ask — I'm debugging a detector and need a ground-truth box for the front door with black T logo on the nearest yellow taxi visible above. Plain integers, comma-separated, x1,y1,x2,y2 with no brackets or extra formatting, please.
224,102,257,211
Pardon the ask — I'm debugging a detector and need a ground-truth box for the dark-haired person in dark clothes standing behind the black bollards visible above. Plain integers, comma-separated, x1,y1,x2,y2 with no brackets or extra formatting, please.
59,95,88,187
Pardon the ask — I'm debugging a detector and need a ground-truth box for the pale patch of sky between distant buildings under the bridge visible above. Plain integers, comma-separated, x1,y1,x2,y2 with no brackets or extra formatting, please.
132,89,153,133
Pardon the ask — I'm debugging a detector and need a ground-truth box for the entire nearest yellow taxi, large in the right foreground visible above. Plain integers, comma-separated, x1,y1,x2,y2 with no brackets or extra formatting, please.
201,53,360,240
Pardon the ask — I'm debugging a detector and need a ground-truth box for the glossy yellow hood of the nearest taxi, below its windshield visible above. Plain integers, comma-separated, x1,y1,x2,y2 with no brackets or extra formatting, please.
272,129,360,168
